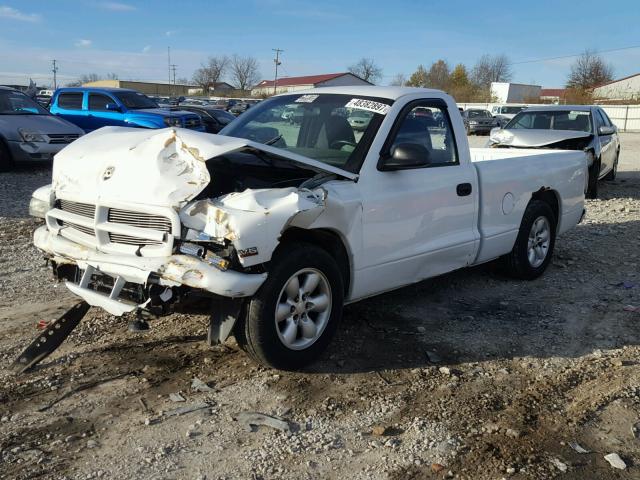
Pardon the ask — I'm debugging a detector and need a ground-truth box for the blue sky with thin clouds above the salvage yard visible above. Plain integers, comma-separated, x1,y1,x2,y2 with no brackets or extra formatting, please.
0,0,640,88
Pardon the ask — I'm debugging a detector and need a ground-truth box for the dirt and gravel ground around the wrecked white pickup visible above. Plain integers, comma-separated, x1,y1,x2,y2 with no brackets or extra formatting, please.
0,134,640,480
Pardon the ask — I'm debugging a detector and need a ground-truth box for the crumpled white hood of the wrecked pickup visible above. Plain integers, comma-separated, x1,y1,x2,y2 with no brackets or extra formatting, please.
52,127,357,208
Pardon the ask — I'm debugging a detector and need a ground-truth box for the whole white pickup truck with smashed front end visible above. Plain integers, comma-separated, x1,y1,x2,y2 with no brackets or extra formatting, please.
30,87,587,369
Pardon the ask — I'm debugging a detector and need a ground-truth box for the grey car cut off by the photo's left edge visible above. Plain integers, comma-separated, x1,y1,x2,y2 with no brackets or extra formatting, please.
0,87,84,171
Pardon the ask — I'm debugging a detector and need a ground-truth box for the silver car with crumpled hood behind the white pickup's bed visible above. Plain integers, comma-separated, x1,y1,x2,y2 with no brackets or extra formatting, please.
489,105,620,198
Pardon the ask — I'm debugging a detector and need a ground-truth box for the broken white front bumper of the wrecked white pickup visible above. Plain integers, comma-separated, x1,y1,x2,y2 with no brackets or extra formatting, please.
33,226,267,315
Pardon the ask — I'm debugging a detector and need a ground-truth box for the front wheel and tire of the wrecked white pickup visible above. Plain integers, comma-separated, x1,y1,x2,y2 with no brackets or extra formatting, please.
236,243,344,370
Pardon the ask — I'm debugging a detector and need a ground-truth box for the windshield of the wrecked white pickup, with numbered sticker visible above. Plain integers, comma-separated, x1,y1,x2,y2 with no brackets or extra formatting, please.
220,94,393,172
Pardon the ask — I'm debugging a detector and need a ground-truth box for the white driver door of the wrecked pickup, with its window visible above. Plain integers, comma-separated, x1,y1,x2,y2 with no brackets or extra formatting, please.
353,100,479,298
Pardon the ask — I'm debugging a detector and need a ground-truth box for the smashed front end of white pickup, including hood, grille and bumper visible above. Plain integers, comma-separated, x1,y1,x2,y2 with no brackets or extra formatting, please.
32,128,354,322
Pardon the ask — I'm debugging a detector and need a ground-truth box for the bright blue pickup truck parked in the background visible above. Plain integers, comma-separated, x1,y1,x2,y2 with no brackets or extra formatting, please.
49,87,205,132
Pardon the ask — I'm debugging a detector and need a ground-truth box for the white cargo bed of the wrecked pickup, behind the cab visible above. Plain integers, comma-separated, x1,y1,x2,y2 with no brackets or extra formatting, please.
470,148,587,263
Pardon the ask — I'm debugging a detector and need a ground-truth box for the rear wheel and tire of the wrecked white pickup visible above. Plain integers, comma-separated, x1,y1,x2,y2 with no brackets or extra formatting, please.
502,200,557,280
